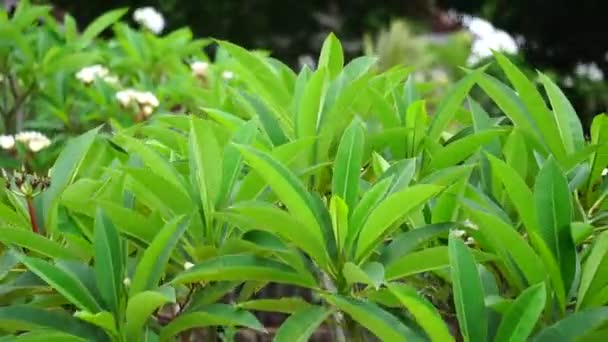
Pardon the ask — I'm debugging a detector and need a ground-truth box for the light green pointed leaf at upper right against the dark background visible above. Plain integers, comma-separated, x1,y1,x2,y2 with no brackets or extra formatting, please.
539,72,585,154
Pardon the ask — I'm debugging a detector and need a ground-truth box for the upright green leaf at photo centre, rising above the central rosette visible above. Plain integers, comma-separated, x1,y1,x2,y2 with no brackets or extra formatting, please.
332,119,365,211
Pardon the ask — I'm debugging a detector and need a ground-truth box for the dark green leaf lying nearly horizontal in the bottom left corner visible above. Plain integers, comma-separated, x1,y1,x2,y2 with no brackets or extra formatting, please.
0,304,109,341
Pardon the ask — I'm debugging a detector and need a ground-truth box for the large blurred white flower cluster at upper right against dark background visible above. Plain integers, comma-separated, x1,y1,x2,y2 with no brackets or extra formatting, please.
462,15,518,65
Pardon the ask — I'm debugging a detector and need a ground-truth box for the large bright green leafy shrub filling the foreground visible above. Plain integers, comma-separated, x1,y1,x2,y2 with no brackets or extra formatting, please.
0,6,608,342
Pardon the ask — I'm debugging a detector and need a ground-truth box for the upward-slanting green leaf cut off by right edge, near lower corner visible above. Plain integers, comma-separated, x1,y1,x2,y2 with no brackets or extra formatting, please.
576,232,608,310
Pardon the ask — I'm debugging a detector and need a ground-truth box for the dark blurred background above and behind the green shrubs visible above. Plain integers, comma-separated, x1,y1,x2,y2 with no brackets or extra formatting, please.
16,0,608,127
